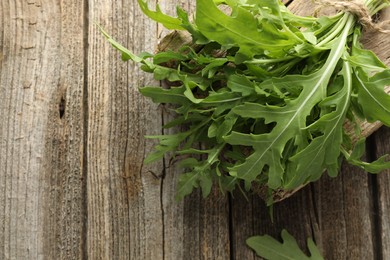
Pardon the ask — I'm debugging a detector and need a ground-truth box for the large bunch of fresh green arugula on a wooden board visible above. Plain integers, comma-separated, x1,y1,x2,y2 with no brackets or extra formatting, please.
103,0,390,199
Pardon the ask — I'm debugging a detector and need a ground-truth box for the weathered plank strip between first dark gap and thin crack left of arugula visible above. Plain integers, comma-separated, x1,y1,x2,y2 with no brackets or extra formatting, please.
87,0,163,259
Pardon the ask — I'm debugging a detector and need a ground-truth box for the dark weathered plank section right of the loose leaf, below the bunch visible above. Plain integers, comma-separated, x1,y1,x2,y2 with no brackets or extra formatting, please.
312,165,376,259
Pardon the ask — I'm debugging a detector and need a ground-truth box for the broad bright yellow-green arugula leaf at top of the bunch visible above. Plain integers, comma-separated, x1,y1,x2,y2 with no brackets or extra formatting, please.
195,0,301,59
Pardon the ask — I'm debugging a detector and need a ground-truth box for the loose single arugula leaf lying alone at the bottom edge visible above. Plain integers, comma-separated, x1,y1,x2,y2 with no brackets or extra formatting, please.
246,229,324,260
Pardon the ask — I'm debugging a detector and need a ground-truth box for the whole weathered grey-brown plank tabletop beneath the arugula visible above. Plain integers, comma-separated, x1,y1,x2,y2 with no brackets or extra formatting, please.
0,0,390,260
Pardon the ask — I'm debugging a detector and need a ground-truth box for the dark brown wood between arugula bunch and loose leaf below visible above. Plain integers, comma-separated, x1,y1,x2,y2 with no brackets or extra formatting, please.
231,186,317,259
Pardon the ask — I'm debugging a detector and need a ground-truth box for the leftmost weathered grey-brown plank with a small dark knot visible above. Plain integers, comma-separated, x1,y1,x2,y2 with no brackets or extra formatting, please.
0,0,84,259
